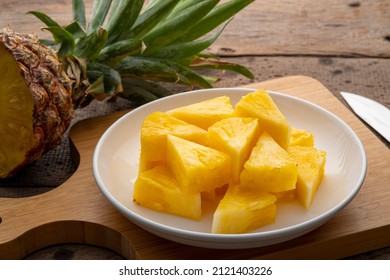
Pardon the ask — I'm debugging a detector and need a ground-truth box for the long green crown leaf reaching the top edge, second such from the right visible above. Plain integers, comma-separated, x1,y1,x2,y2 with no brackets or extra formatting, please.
144,0,218,54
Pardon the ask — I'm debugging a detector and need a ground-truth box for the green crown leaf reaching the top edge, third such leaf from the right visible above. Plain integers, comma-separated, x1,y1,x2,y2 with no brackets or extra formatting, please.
122,0,180,38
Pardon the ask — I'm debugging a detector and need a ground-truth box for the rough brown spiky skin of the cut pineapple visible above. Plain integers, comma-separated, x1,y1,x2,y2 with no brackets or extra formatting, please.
0,28,74,177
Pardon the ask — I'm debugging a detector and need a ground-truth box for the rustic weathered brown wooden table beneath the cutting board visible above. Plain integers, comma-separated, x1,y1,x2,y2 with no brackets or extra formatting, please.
0,0,390,259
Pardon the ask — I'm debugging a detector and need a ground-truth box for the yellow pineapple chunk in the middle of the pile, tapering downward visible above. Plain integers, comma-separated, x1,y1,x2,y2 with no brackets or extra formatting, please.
208,117,261,181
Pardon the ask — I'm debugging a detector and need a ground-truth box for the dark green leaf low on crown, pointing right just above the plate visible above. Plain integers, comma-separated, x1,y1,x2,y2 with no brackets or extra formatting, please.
115,56,212,88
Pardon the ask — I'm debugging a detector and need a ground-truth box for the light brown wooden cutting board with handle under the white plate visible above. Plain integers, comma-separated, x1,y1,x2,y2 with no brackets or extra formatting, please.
0,76,390,259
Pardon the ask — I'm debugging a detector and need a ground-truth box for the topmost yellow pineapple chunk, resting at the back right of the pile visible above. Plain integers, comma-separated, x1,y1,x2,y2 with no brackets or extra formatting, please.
235,89,291,150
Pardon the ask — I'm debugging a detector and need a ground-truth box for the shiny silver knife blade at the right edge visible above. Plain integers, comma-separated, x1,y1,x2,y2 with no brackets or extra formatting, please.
340,91,390,142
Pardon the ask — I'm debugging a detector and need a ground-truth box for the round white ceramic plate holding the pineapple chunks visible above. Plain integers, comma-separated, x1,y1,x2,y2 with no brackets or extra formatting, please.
93,88,366,249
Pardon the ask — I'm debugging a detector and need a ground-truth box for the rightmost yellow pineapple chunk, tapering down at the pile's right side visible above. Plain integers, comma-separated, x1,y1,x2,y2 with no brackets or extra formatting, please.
289,146,326,209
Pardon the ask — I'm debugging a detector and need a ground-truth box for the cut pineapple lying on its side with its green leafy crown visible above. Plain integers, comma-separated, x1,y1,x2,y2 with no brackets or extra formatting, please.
0,0,253,178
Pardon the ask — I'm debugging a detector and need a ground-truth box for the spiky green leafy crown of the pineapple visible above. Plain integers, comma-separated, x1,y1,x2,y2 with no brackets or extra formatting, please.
29,0,254,106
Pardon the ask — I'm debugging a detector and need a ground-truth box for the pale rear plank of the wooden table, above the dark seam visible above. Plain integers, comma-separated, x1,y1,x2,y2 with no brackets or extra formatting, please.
0,0,390,58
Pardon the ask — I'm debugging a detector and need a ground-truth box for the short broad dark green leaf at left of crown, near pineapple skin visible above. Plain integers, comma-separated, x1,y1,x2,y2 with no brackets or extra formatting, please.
74,28,108,60
